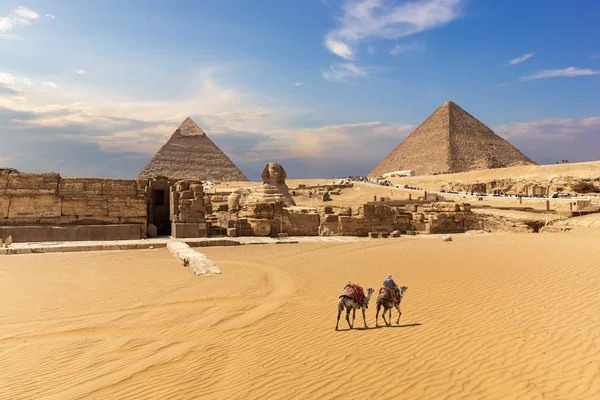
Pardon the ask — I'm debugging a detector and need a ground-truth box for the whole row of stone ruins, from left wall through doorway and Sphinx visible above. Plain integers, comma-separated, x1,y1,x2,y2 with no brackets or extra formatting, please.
0,163,479,242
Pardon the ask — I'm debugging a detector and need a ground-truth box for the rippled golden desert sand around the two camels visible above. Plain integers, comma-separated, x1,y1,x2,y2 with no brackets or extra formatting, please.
0,233,600,399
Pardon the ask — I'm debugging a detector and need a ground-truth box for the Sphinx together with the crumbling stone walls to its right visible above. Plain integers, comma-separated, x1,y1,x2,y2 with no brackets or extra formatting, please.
211,163,478,237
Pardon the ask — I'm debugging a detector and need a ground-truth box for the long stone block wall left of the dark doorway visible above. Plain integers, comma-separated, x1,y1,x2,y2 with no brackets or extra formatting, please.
0,169,147,242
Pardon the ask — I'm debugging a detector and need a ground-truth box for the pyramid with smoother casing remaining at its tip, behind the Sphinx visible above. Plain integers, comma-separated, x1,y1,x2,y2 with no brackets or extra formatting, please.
137,117,248,182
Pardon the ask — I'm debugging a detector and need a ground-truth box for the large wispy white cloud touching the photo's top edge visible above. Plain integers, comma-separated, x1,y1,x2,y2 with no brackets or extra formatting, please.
325,0,464,59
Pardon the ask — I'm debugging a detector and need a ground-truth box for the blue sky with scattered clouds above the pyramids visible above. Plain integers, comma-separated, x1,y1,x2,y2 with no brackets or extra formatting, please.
0,0,600,180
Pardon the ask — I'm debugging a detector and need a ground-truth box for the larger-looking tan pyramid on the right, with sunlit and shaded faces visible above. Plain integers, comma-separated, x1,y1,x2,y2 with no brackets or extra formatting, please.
368,101,535,176
